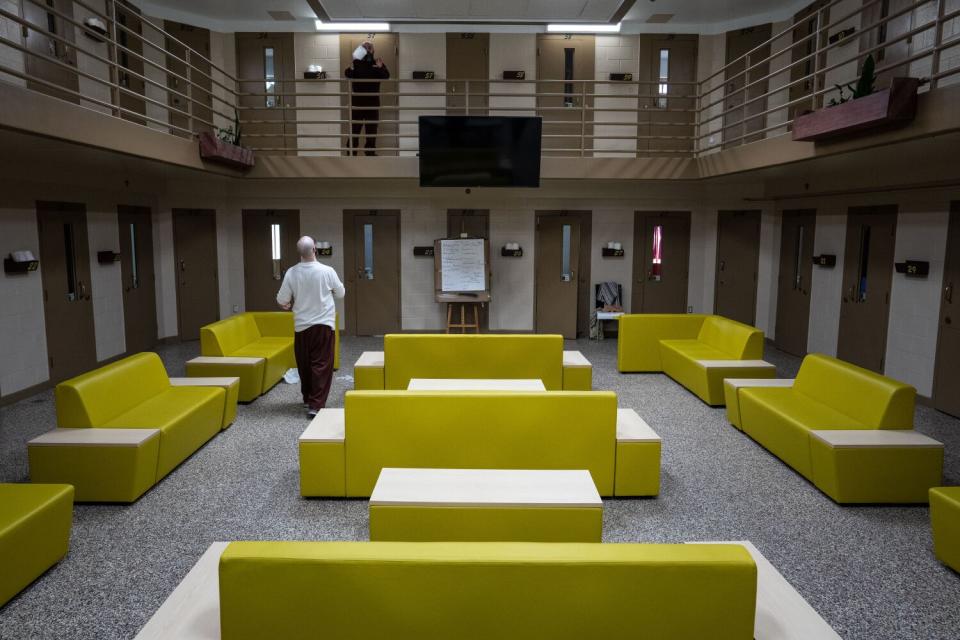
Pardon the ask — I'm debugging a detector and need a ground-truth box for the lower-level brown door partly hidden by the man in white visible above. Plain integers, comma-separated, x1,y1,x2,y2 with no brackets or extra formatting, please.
243,209,300,311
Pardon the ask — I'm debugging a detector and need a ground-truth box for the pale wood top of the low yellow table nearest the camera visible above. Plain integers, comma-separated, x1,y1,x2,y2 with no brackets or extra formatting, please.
370,468,603,508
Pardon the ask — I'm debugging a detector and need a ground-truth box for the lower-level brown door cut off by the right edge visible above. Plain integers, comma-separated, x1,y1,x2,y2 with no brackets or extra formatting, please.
933,202,960,416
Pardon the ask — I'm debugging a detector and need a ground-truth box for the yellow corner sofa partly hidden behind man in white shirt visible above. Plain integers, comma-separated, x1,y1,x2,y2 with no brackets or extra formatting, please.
195,311,340,402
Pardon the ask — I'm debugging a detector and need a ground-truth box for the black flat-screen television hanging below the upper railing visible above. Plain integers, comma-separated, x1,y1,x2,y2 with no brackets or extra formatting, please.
420,116,542,187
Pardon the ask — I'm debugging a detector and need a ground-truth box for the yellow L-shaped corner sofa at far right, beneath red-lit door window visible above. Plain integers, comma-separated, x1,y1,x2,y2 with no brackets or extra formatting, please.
617,314,776,405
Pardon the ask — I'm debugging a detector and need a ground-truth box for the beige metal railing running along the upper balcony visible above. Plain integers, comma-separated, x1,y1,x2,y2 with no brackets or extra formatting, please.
0,0,960,157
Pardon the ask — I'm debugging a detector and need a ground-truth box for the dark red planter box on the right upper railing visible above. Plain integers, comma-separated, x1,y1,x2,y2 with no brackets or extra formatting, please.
793,78,920,141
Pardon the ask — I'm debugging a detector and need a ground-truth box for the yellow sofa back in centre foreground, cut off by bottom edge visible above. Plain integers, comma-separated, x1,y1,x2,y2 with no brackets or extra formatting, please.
219,542,757,640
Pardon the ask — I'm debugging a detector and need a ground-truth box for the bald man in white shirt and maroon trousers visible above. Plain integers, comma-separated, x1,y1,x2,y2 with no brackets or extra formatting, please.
277,236,345,418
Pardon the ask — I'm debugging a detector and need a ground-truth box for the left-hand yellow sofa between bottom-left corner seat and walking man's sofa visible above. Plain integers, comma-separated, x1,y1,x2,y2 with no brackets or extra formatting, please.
28,352,227,502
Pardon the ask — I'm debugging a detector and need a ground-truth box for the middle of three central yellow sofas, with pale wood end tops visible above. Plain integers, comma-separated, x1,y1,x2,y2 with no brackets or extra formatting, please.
299,391,661,497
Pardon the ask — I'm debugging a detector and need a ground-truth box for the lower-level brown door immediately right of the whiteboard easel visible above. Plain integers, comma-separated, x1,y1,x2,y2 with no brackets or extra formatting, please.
534,213,581,340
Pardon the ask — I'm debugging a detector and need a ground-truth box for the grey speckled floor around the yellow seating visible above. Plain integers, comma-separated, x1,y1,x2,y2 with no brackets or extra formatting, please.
0,338,960,640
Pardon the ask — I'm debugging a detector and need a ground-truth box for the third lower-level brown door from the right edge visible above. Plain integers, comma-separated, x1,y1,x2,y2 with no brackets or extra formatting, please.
776,209,817,356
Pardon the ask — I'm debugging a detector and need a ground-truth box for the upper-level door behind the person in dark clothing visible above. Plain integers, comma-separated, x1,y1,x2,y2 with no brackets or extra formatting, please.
340,33,398,156
